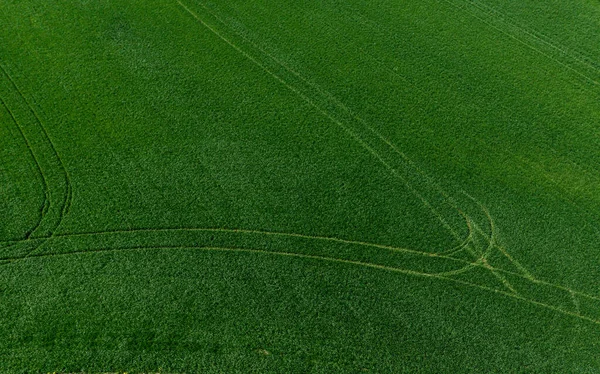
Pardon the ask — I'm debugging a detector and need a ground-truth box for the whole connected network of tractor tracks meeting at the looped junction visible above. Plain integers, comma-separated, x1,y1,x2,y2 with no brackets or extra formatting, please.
0,1,600,334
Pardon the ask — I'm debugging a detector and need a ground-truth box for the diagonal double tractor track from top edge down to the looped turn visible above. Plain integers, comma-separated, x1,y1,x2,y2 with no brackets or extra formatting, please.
178,1,532,280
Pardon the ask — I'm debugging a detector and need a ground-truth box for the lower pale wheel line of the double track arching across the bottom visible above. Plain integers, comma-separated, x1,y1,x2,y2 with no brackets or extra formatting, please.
11,246,600,325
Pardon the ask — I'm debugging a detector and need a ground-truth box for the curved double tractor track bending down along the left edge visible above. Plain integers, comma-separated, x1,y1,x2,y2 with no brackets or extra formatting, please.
0,64,71,253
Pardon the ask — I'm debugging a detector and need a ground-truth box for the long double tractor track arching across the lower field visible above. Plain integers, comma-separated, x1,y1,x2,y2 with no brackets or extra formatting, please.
3,228,600,325
